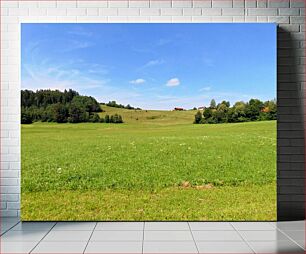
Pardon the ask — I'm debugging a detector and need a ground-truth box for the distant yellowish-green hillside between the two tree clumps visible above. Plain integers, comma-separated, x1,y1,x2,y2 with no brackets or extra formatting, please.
99,105,197,125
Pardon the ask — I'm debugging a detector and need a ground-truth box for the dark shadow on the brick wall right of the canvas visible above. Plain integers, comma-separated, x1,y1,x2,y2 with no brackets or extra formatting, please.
277,27,305,221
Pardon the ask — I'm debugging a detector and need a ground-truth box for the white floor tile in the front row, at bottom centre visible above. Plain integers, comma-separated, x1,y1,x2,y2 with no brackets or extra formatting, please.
143,241,198,254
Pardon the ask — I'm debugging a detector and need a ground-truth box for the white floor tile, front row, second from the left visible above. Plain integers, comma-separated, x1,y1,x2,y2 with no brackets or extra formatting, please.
32,242,87,254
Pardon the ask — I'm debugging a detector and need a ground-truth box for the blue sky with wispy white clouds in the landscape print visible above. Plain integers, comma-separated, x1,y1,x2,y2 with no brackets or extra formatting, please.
21,24,276,109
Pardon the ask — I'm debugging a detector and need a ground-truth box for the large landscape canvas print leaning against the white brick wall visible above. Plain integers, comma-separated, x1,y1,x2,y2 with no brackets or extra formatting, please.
21,23,277,221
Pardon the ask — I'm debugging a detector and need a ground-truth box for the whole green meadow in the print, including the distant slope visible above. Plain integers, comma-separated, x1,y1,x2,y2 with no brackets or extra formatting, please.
22,106,276,220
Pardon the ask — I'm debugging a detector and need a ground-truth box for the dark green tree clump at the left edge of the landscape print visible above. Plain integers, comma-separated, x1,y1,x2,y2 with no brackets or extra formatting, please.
21,89,123,124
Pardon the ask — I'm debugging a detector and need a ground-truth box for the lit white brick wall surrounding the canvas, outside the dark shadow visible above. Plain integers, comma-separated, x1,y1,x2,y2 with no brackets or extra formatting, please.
0,0,305,216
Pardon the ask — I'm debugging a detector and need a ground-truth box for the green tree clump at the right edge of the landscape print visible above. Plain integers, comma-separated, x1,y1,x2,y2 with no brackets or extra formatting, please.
194,99,277,124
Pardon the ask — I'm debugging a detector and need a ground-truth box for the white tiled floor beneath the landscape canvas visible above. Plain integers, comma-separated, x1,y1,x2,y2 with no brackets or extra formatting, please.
0,218,305,254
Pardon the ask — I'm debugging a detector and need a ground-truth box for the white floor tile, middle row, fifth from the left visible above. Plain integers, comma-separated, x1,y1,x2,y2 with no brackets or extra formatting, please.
192,231,243,241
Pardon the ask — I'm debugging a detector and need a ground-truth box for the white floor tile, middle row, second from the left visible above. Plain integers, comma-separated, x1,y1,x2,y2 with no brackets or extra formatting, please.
42,230,92,242
